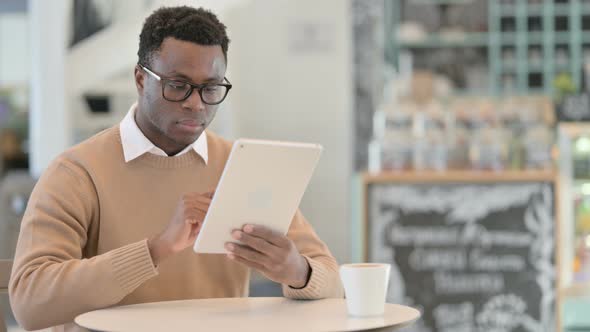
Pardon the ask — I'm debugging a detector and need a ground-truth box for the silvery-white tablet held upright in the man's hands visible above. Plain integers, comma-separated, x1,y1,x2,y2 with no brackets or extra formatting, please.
193,139,322,254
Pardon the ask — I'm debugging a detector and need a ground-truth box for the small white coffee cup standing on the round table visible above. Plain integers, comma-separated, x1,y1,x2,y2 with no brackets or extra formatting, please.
340,263,391,317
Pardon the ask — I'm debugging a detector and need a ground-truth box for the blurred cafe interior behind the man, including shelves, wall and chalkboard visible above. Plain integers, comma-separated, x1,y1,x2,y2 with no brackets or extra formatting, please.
0,0,590,332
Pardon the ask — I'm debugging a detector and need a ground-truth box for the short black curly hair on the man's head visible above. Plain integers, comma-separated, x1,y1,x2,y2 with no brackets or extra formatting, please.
137,6,229,66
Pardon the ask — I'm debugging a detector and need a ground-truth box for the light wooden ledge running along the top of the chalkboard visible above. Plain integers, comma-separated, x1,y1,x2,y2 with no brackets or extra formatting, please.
362,170,557,183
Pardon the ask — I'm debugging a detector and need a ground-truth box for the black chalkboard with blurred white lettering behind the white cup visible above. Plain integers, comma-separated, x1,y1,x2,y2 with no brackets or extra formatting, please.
366,181,557,332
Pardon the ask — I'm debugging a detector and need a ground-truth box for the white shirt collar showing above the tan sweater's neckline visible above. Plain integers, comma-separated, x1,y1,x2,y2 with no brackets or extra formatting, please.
119,102,208,164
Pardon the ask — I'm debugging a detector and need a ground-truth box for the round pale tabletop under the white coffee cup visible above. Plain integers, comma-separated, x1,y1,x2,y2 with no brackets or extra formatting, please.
75,297,420,332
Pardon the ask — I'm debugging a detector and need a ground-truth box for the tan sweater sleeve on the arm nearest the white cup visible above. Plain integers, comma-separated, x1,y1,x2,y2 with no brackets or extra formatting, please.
283,210,344,300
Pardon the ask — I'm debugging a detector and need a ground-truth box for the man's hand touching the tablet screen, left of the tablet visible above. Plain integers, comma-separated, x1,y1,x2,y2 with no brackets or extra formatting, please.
148,192,213,265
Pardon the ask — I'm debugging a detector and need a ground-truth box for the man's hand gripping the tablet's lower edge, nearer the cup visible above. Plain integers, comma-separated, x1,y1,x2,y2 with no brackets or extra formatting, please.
225,225,310,288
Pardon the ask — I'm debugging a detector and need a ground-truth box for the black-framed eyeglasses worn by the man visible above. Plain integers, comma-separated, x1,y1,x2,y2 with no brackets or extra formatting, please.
137,63,232,105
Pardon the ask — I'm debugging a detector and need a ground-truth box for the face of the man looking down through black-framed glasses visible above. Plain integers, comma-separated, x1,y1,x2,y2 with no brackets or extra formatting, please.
135,37,226,153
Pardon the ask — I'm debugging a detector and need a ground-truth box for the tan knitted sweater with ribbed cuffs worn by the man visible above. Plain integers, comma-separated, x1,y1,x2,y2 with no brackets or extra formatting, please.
9,126,343,330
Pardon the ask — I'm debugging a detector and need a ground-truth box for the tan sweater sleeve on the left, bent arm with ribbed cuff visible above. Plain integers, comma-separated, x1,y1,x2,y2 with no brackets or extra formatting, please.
9,157,157,330
